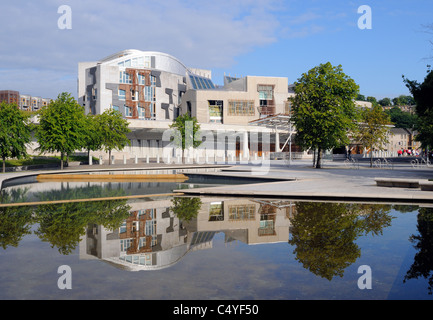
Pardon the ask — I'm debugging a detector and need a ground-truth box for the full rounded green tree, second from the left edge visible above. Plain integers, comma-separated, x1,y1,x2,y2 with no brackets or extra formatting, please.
36,92,86,169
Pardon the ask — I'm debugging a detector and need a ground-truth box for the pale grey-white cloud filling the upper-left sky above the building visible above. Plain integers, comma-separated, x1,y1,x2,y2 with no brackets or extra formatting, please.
0,0,281,93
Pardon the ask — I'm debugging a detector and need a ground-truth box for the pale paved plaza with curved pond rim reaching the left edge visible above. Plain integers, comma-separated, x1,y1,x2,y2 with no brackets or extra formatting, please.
0,160,433,205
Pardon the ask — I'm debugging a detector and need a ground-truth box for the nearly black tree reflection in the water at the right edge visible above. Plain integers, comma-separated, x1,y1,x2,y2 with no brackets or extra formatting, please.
403,208,433,295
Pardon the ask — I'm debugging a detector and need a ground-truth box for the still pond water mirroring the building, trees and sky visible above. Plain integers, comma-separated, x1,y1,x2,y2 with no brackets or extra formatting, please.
0,178,433,300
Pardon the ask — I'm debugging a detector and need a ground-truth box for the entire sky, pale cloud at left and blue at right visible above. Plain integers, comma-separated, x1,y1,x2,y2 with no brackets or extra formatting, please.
0,0,433,99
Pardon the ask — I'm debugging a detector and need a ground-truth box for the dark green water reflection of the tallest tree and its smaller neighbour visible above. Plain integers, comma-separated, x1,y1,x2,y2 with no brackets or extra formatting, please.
289,202,392,280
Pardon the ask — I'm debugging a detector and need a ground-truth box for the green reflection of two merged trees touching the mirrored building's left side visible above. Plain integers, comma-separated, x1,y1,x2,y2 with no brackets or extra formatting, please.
35,200,131,254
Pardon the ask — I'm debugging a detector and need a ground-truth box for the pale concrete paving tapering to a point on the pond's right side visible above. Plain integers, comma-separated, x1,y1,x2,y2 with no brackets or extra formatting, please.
177,161,433,203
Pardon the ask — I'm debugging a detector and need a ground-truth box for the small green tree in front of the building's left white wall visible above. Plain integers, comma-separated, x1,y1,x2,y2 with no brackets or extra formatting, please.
98,109,131,165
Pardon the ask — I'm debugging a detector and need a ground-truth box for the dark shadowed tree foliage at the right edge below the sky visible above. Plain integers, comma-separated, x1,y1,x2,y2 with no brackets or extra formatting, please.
403,70,433,148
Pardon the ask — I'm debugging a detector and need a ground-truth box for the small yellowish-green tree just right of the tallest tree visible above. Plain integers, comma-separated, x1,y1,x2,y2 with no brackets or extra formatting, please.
357,105,391,167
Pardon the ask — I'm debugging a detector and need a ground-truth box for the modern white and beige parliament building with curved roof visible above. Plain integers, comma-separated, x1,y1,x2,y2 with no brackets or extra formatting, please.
78,50,364,162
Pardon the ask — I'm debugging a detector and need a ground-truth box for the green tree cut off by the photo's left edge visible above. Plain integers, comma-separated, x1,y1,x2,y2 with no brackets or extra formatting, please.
0,102,31,172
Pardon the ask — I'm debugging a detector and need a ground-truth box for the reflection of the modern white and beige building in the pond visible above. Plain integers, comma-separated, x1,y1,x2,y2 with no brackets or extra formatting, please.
80,198,294,271
